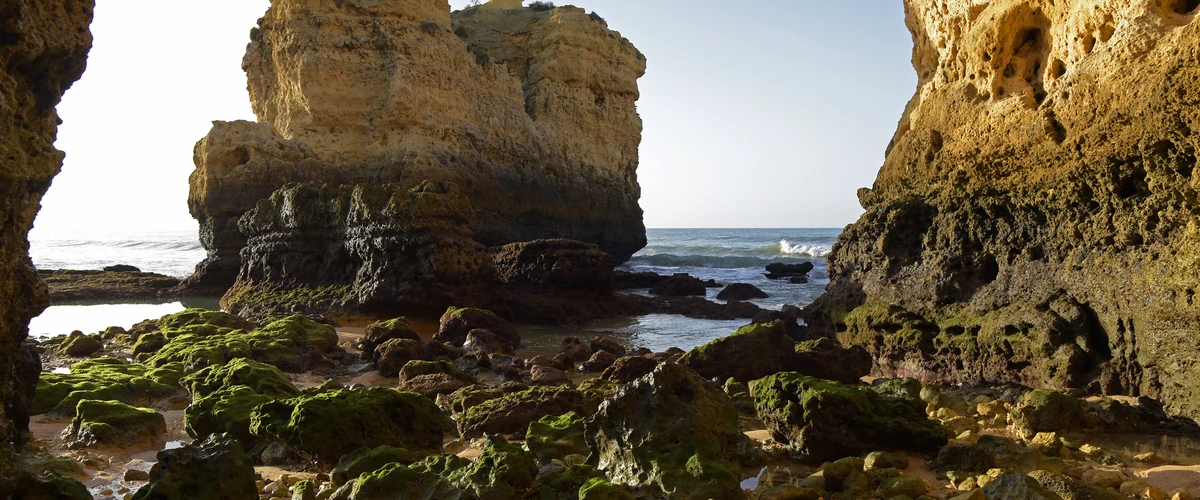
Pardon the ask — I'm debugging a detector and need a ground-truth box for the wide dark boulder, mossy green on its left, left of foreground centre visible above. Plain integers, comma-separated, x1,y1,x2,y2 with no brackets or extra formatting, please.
250,387,452,464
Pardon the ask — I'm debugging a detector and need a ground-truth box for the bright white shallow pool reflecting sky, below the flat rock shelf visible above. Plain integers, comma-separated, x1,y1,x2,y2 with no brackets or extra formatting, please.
29,299,220,338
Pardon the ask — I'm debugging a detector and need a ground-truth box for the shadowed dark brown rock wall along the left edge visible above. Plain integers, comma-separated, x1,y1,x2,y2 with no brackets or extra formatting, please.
0,0,95,446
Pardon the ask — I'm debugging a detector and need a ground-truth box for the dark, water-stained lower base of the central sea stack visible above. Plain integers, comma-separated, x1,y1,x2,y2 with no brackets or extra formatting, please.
221,182,503,317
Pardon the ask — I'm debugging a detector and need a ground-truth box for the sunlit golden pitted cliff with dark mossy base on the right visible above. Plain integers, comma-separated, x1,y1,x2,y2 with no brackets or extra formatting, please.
808,0,1200,416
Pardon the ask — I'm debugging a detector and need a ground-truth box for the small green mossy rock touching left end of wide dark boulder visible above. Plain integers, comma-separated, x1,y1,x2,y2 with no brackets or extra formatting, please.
184,385,275,446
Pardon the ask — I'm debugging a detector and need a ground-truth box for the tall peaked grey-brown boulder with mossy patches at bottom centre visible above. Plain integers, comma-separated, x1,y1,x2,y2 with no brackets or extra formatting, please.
584,363,746,499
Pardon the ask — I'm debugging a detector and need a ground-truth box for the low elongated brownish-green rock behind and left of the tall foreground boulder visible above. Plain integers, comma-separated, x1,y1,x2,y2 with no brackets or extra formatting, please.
458,386,600,438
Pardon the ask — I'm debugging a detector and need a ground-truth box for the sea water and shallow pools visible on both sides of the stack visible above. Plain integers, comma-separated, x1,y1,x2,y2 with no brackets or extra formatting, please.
30,229,841,353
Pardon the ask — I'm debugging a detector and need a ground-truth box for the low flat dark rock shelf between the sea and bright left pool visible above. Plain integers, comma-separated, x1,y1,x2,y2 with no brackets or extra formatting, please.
37,266,179,303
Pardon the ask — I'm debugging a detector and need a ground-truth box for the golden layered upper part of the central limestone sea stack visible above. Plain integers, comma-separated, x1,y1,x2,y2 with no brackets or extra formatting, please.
184,0,646,294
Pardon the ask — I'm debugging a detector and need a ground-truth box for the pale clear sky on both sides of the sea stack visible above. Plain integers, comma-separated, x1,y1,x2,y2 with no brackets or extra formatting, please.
35,0,916,235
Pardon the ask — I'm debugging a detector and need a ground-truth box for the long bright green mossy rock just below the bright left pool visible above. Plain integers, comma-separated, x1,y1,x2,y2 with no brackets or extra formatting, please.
144,314,337,371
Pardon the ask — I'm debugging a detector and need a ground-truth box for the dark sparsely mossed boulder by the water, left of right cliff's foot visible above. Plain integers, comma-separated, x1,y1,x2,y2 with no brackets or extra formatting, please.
678,323,796,382
